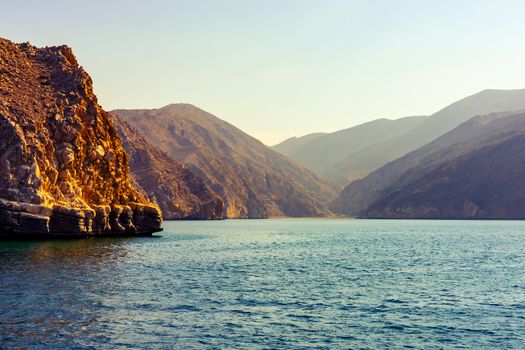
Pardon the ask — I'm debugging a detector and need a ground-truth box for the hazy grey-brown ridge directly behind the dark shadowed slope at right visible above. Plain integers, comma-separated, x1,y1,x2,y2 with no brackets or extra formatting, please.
332,112,525,215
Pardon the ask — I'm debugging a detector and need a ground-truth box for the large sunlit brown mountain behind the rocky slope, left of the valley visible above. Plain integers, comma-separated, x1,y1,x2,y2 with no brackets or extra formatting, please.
114,104,335,218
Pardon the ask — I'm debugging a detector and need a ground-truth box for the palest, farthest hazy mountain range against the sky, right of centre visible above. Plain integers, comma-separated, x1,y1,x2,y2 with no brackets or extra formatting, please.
272,89,525,183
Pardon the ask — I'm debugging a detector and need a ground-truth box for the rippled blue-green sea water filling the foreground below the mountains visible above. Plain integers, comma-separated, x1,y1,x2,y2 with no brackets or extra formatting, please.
0,220,525,349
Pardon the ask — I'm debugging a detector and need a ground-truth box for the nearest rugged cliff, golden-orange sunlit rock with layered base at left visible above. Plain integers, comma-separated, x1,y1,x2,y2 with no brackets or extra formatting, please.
0,38,162,236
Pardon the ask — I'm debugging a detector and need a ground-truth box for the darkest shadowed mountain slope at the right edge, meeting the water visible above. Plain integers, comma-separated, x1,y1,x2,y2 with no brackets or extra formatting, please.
364,135,525,219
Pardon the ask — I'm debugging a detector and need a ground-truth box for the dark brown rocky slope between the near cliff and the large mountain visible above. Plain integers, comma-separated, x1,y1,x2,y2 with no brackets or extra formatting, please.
111,114,224,220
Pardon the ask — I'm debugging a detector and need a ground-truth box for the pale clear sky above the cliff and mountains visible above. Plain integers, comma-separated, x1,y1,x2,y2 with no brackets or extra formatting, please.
0,0,525,145
